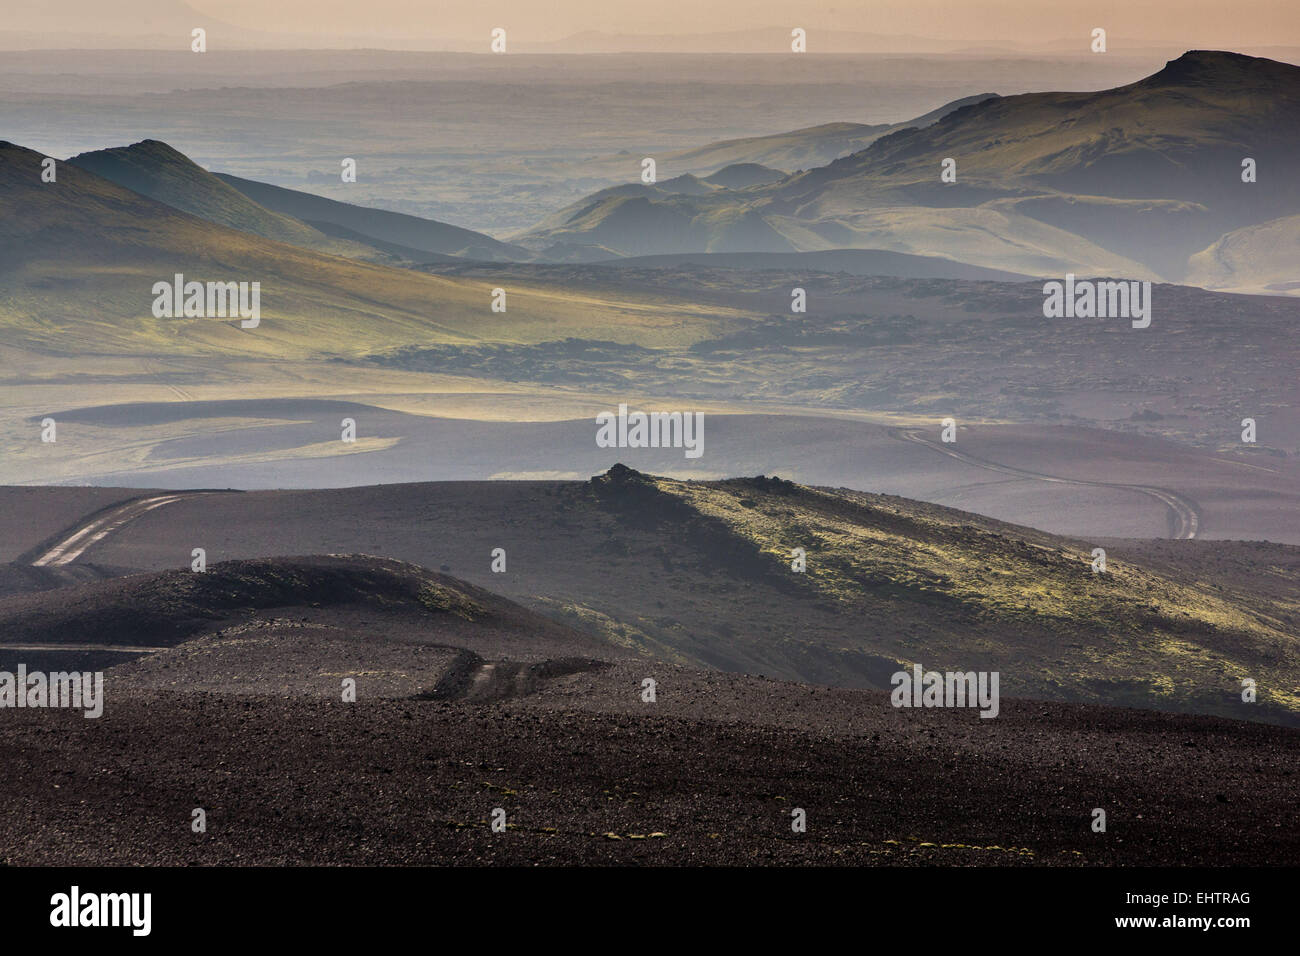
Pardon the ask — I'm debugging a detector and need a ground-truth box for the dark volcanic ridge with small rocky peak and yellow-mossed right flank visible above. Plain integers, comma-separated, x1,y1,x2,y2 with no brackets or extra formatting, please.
12,467,1300,722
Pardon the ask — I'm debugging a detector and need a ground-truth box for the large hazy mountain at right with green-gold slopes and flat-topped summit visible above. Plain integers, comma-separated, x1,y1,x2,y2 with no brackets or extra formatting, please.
516,51,1300,291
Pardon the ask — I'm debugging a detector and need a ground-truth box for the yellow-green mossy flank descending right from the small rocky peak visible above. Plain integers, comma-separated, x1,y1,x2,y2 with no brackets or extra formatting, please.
594,472,1300,719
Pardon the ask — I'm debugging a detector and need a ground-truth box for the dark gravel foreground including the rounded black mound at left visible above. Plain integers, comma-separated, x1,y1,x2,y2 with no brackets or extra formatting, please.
0,557,1300,865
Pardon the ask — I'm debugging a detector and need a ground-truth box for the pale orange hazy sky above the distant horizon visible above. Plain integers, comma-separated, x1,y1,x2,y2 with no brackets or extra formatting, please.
10,0,1300,52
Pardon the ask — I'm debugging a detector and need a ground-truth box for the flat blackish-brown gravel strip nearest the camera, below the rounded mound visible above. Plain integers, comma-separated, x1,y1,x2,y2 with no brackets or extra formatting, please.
0,678,1300,865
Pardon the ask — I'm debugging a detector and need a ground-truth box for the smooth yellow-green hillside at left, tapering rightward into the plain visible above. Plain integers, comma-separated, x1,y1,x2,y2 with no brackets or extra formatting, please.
0,143,736,359
